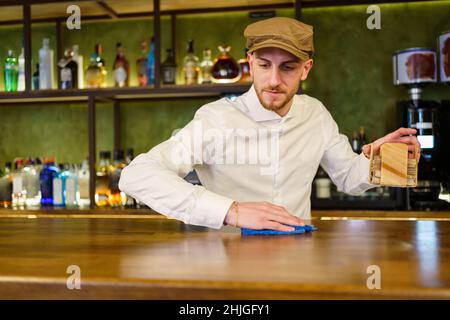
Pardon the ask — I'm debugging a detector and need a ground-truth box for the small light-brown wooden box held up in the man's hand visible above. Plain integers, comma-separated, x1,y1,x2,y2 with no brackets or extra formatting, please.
369,143,419,188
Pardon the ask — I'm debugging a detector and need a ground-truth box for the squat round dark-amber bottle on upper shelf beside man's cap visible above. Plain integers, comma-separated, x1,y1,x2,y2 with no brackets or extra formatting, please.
211,45,242,83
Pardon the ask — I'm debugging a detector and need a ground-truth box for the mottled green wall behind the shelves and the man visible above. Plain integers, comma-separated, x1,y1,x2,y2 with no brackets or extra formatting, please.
0,1,450,168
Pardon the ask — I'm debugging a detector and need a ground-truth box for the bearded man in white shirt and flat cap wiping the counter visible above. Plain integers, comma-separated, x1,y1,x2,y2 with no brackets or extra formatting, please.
119,17,419,231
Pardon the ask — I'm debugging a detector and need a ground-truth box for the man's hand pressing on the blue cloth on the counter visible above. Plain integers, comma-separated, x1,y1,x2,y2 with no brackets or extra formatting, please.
224,202,305,231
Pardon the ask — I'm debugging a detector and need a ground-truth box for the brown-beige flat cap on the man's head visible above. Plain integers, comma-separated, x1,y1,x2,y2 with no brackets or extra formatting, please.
244,17,314,60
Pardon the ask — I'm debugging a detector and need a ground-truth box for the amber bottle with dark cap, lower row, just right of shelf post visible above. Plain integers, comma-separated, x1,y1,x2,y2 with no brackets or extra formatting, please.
95,151,112,207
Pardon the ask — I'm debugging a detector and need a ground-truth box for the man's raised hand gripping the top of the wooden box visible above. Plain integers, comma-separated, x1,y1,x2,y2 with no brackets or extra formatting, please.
362,128,420,161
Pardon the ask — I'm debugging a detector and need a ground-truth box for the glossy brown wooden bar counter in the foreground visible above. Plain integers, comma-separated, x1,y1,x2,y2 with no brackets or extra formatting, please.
0,210,450,299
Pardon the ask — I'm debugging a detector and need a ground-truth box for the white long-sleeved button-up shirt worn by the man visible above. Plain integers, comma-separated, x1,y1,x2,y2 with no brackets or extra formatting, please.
119,86,374,229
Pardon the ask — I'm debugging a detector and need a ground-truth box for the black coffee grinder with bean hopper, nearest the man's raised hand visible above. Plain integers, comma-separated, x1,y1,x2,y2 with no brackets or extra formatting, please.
393,48,448,210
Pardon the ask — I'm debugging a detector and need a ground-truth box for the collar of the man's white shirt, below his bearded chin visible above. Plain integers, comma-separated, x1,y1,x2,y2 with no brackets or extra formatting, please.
242,85,298,122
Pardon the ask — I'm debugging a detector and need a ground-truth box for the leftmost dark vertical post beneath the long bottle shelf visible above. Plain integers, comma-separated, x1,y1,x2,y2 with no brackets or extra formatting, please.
88,96,97,208
